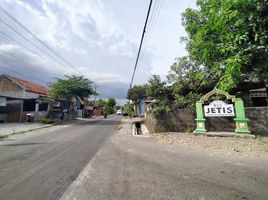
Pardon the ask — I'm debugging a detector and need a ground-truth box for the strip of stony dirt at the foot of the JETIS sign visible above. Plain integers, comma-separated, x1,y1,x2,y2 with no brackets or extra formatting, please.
152,132,268,157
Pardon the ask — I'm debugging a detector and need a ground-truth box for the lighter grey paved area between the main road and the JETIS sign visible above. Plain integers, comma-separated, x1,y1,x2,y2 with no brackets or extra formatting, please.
61,121,268,200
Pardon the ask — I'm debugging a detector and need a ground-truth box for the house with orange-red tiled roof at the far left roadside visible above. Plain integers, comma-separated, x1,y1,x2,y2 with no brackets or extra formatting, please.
0,74,48,122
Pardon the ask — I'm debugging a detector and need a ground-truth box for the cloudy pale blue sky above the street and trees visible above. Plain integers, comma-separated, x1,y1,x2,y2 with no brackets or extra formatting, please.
0,0,195,104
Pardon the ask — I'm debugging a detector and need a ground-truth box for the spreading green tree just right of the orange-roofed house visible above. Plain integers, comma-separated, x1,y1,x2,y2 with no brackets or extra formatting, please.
48,75,96,100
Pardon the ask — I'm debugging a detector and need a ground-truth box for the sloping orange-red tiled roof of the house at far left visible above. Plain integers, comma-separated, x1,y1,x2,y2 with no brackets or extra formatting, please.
7,75,48,95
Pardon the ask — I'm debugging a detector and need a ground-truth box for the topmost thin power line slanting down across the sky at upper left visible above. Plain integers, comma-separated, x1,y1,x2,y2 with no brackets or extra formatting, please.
0,6,81,74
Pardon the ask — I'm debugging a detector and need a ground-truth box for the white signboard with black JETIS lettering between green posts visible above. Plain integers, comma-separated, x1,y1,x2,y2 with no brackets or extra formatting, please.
204,101,234,117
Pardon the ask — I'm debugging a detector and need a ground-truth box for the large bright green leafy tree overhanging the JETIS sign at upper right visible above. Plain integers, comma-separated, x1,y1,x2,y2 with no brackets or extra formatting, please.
182,0,268,90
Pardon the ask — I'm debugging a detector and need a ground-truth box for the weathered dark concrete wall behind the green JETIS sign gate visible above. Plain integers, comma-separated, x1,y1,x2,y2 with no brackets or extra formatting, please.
145,107,268,135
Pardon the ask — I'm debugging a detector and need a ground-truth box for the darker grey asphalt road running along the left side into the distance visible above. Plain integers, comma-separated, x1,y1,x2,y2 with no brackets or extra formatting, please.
0,116,120,200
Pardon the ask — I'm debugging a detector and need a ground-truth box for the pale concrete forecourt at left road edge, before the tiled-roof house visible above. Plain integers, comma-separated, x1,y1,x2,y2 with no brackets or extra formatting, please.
0,123,52,137
